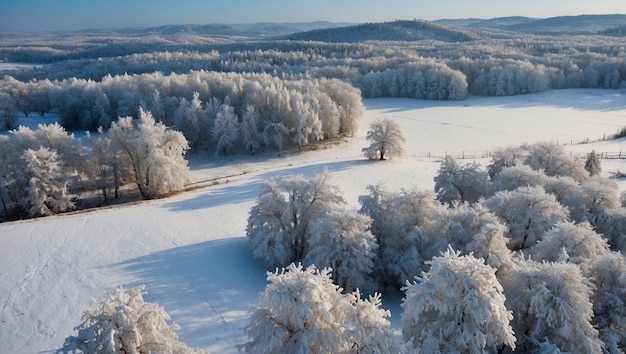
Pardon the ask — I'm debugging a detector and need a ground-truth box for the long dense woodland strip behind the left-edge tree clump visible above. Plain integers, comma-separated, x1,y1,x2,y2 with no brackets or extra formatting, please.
0,70,364,154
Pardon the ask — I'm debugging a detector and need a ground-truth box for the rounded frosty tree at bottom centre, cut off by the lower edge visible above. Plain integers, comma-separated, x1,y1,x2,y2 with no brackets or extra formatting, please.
241,263,348,353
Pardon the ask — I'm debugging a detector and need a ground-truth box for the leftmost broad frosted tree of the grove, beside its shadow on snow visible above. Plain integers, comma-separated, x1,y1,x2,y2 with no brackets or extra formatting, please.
246,173,345,269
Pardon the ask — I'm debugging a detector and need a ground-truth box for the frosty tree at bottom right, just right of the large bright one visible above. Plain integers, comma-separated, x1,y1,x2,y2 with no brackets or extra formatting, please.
498,260,604,354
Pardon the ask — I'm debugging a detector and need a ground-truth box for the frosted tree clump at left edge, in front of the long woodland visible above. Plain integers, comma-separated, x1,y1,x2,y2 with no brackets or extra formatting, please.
0,109,189,220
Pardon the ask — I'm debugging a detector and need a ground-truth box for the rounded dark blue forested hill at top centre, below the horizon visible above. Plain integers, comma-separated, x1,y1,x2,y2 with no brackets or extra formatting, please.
283,20,477,43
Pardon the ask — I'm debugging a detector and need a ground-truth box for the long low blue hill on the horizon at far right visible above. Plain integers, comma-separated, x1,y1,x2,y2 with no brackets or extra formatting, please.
435,15,626,34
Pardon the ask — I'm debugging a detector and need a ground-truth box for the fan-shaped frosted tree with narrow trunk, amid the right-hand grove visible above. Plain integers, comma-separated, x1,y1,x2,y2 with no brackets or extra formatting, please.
482,187,569,251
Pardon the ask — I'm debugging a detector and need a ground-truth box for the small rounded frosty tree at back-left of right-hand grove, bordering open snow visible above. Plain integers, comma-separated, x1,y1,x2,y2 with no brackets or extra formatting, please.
434,155,489,204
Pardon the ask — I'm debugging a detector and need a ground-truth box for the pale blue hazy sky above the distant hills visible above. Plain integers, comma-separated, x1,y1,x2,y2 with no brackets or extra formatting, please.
0,0,626,32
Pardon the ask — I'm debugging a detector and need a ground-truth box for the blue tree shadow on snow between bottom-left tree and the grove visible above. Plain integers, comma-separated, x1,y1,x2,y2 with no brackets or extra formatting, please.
111,237,267,352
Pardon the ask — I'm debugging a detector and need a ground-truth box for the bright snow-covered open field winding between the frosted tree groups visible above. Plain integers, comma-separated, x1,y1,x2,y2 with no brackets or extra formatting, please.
0,89,626,353
